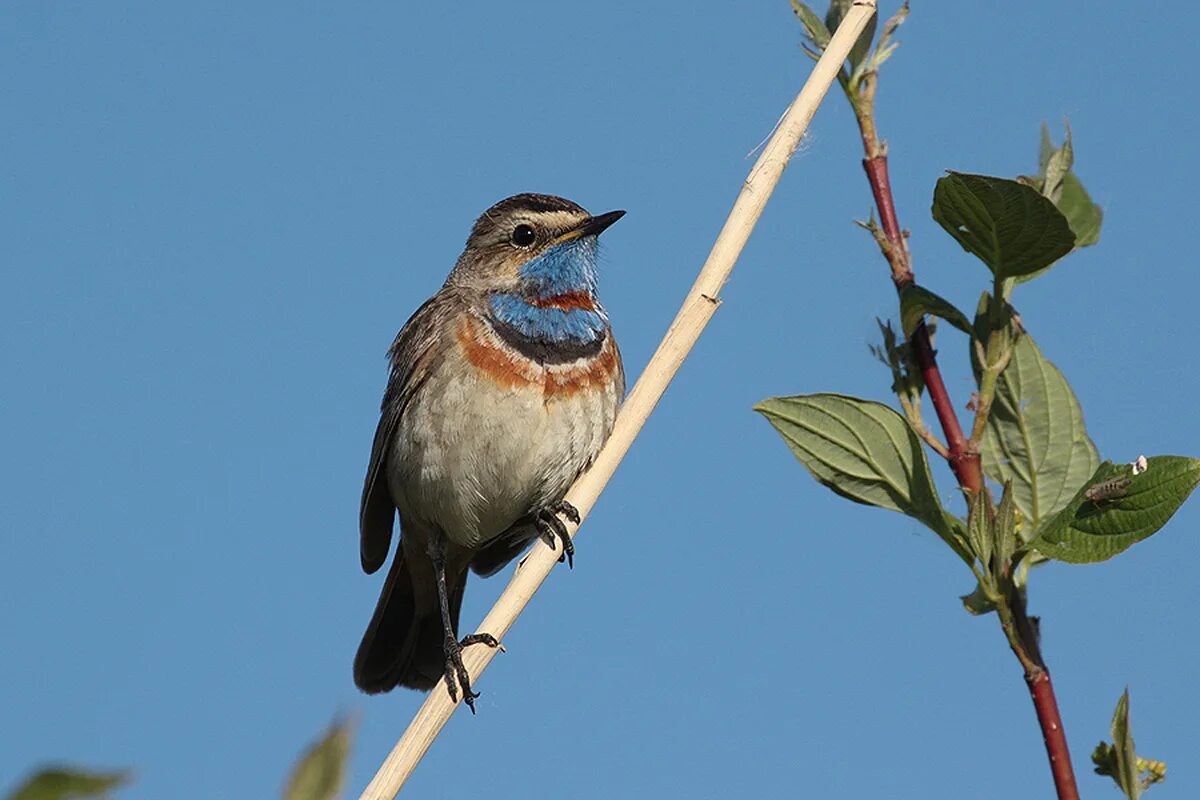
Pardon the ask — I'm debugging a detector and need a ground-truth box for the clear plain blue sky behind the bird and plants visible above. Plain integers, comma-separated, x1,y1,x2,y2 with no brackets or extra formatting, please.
0,0,1200,800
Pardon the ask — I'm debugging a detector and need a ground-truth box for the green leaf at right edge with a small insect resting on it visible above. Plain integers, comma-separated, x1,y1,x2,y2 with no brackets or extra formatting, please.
1030,456,1200,564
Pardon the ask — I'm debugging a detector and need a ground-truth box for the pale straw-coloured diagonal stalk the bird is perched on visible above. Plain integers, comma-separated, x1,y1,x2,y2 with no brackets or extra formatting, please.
361,0,875,800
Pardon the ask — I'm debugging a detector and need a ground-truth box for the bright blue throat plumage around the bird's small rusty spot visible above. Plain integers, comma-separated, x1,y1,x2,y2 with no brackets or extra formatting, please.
490,236,608,344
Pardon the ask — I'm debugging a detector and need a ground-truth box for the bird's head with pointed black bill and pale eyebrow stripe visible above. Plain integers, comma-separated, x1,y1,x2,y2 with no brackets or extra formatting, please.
450,194,625,297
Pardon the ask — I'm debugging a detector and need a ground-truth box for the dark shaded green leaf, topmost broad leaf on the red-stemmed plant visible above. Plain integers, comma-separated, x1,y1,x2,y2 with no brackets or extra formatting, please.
934,172,1075,278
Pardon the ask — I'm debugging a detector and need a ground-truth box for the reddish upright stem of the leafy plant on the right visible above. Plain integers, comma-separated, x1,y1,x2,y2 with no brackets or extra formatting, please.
856,151,1079,800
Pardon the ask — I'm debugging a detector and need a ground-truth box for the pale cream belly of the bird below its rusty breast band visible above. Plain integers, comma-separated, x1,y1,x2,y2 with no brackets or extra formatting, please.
389,368,618,547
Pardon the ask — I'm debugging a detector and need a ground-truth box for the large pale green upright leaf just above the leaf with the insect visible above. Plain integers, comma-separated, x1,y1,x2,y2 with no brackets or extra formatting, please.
979,333,1100,531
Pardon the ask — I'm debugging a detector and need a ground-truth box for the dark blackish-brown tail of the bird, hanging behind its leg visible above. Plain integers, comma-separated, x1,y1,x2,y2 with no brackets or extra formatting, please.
354,541,467,694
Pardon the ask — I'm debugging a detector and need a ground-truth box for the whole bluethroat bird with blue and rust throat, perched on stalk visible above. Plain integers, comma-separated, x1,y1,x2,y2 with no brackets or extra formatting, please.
354,194,625,711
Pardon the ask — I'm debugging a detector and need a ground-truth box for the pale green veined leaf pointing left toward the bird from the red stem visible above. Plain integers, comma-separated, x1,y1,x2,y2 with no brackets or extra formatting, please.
754,393,971,564
